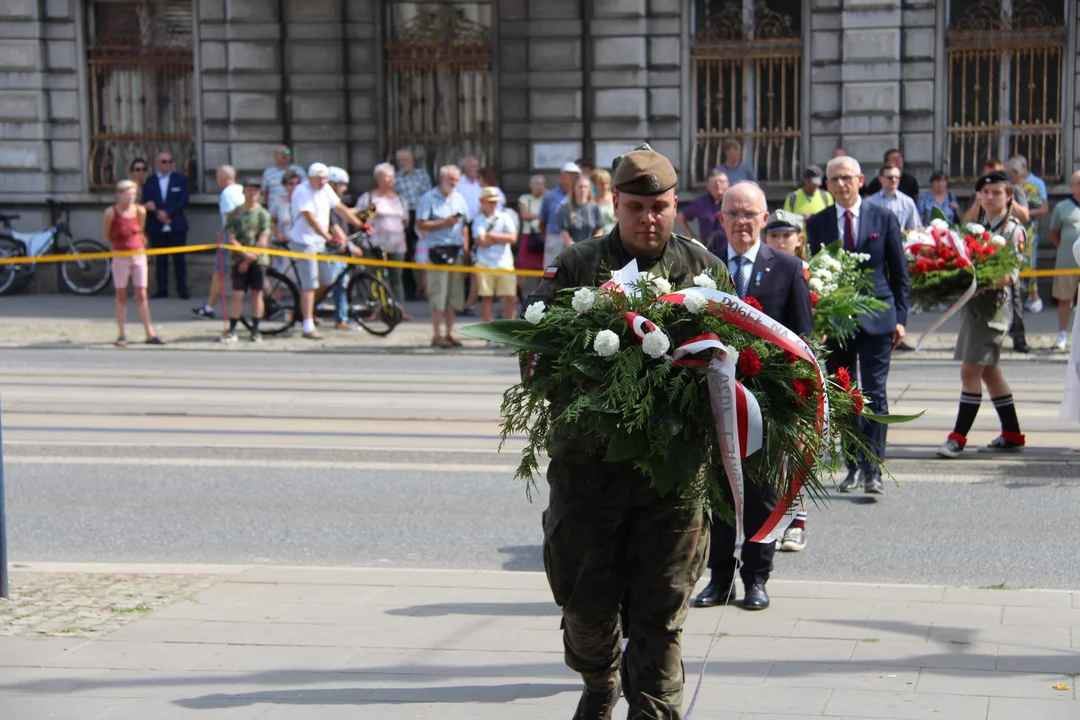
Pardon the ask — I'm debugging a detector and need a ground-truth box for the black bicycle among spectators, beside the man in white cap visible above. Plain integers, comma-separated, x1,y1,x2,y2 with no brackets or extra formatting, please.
240,231,402,337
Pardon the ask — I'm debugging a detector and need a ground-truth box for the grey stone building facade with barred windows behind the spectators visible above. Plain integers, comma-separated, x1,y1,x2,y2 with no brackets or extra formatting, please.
0,0,1080,234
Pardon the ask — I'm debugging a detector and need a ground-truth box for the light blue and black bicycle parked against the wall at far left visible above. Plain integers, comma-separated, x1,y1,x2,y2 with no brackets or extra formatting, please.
0,200,112,295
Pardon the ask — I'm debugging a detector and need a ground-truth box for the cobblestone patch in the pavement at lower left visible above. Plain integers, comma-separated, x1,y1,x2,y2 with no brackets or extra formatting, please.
0,566,222,638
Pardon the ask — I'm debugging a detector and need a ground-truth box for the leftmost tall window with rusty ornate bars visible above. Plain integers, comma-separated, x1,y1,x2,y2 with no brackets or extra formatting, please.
87,0,195,189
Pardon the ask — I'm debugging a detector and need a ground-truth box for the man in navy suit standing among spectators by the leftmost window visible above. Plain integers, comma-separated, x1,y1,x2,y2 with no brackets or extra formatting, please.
143,152,190,299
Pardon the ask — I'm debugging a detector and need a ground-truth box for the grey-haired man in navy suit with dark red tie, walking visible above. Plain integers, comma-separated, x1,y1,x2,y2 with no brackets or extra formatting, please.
807,158,910,494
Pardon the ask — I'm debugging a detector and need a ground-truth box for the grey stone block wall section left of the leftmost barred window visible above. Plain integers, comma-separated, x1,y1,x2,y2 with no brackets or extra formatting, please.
0,0,86,195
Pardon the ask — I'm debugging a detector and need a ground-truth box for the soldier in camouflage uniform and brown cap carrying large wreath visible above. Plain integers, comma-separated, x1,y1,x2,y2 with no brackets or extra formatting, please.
526,146,726,720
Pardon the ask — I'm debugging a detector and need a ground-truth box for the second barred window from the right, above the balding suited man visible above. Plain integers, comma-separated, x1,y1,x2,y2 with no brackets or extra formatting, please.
691,0,802,186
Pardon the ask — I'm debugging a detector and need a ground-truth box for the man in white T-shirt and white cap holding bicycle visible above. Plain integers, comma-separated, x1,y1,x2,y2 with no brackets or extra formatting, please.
288,163,363,340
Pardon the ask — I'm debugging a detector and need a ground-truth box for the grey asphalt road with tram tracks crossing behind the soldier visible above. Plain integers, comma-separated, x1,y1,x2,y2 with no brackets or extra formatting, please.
0,350,1080,588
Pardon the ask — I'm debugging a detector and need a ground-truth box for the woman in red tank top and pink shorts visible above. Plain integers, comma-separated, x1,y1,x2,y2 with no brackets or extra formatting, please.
104,180,165,348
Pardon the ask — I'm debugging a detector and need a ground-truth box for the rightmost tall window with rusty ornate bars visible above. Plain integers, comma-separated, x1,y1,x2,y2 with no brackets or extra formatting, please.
946,0,1066,180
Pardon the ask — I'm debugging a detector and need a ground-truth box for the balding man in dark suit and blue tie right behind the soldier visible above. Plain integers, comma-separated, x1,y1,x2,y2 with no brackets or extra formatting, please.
693,182,813,610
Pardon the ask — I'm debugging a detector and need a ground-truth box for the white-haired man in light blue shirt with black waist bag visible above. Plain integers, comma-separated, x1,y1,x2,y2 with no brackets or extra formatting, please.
416,165,469,348
